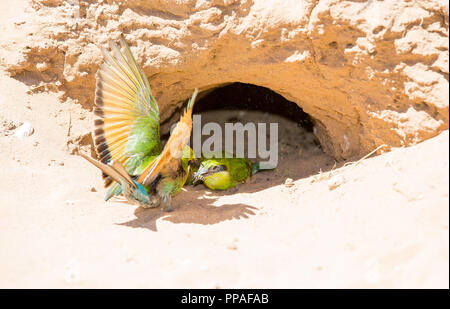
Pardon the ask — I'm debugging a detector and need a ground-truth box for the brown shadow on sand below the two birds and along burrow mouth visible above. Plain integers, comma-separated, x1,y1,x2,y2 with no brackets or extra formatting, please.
119,146,344,232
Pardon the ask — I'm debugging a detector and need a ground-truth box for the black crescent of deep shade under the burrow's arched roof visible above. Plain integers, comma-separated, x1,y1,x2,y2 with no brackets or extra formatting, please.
194,83,313,132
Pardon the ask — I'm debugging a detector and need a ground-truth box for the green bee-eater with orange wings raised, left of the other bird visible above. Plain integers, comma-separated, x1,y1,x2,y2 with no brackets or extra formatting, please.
79,36,198,210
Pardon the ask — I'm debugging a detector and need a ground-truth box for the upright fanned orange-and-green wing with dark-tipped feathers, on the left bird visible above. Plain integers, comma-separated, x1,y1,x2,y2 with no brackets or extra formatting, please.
94,36,161,187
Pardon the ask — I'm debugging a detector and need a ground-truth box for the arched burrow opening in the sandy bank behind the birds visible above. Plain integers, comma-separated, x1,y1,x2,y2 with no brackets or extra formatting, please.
182,83,334,185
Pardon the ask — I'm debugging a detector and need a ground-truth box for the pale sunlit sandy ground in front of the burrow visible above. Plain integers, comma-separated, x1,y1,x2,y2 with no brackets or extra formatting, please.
0,69,449,288
